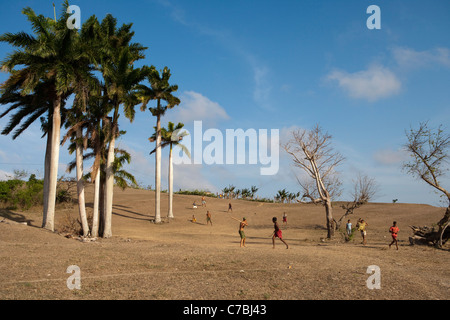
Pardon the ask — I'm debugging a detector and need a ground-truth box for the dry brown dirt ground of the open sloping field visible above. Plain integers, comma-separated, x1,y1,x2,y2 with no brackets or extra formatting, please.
0,186,450,300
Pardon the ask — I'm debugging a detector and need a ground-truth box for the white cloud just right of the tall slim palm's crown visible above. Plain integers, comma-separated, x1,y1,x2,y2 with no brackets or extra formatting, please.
171,91,230,125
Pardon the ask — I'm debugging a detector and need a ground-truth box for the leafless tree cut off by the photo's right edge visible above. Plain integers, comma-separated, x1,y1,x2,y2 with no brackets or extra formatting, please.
403,122,450,247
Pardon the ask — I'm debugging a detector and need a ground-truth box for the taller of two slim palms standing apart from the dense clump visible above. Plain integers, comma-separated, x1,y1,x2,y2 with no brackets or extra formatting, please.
137,67,180,223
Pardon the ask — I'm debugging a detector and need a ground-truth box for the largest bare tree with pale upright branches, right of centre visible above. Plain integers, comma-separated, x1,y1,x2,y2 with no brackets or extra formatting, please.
283,125,344,238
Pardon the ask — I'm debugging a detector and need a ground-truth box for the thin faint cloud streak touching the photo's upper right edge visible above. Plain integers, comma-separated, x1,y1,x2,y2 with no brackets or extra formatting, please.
392,47,450,69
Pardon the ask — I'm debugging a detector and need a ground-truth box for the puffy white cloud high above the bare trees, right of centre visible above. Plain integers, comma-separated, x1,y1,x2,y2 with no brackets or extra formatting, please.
327,65,402,102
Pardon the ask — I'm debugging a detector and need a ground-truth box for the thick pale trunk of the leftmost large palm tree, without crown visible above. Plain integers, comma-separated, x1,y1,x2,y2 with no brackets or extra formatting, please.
42,96,61,231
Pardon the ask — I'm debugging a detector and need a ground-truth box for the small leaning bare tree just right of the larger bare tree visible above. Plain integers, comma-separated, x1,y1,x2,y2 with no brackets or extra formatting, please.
336,173,378,229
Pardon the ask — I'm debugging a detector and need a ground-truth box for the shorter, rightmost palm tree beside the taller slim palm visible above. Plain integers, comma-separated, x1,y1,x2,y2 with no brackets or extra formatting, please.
149,122,191,218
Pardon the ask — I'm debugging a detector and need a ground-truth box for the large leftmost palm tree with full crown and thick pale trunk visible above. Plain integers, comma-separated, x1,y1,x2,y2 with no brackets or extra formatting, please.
0,1,94,231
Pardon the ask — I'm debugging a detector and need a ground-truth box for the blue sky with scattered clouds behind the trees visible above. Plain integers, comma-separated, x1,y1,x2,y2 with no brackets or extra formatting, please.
0,0,450,205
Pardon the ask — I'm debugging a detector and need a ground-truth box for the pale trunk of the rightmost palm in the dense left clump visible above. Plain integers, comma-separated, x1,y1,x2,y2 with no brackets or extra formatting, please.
103,134,116,238
